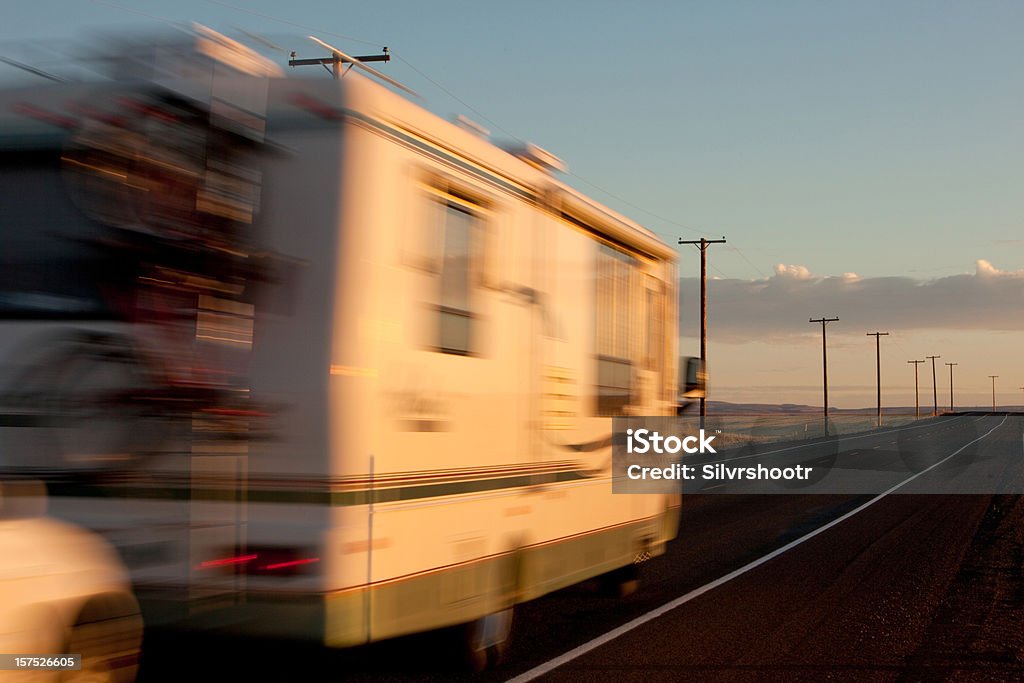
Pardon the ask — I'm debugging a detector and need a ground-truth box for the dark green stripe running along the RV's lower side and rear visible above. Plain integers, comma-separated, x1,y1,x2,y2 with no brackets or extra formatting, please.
48,470,590,507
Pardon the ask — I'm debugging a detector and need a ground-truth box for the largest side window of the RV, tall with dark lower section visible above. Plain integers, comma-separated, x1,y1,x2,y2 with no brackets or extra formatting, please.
595,245,637,416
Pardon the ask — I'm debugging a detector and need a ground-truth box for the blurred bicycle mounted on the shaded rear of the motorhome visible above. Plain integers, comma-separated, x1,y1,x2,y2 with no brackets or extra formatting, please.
0,88,284,476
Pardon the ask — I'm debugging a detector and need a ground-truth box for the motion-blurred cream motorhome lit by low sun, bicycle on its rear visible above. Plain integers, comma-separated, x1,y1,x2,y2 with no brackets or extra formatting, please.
0,29,680,660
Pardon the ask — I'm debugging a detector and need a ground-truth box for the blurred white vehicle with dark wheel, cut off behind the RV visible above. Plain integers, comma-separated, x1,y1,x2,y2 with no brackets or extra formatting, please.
0,481,142,682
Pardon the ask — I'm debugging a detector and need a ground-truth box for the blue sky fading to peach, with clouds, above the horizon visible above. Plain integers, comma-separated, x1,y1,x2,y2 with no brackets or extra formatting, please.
0,0,1024,408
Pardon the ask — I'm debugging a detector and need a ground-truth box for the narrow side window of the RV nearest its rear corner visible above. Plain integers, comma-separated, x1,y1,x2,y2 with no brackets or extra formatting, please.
437,201,480,355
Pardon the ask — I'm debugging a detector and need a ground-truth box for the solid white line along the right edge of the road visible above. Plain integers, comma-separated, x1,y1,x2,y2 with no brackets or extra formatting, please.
507,416,1009,683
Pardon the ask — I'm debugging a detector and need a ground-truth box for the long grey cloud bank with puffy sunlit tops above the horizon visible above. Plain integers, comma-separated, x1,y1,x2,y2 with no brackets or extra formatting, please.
680,260,1024,342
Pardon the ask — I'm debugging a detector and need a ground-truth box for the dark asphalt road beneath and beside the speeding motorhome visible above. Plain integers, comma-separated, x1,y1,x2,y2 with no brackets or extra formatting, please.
140,417,1024,681
